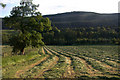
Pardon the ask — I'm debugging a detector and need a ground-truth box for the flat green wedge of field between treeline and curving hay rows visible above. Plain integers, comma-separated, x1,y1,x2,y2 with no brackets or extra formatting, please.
49,45,119,62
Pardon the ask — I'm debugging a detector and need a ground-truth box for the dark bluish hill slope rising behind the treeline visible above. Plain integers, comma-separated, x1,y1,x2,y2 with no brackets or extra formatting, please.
44,12,118,28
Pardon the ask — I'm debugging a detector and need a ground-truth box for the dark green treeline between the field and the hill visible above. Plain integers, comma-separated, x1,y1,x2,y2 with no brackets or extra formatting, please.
43,27,120,45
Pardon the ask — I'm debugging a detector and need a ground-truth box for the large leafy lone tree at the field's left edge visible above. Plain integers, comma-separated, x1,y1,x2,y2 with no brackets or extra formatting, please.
5,0,52,54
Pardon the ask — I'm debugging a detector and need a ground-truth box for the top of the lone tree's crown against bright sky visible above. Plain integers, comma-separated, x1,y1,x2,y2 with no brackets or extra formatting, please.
11,0,40,17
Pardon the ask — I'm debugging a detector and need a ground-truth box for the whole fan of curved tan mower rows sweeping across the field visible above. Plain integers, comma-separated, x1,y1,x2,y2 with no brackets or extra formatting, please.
12,47,118,78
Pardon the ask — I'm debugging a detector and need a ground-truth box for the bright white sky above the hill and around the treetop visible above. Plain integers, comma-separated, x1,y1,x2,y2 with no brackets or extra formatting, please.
0,0,120,17
